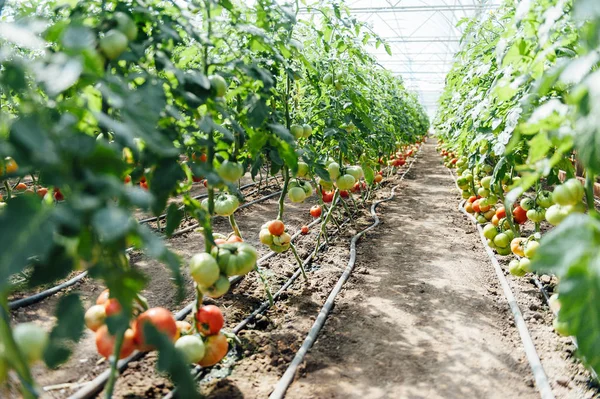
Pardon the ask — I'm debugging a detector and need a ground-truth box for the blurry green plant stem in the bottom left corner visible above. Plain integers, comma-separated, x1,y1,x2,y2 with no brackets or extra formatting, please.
0,293,38,399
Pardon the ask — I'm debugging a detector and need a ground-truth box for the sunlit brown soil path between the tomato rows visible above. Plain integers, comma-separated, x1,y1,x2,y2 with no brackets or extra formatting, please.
286,142,539,399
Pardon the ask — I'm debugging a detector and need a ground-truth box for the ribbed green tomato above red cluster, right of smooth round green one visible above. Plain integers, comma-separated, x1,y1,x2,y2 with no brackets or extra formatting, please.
212,242,258,277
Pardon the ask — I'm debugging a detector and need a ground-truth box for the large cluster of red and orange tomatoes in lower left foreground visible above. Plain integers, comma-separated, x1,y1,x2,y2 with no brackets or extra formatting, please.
85,290,228,366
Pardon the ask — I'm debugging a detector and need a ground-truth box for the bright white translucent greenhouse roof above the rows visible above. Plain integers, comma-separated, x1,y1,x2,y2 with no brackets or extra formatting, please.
301,0,500,115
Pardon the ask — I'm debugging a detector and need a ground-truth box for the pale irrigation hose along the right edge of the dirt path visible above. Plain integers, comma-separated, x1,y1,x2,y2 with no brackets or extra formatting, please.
458,201,554,399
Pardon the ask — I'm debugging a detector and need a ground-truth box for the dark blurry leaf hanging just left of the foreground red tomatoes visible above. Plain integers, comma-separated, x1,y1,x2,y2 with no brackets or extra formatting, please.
44,293,85,368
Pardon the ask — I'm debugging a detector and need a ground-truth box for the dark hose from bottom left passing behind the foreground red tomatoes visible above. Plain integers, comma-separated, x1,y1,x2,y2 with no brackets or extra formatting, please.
68,209,332,399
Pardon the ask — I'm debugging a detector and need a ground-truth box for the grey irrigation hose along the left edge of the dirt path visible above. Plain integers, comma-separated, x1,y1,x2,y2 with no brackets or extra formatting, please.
269,153,418,399
